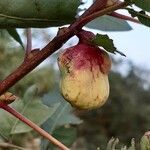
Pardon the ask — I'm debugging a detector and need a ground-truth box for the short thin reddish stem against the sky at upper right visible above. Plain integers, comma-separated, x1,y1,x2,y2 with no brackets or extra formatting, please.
109,12,141,24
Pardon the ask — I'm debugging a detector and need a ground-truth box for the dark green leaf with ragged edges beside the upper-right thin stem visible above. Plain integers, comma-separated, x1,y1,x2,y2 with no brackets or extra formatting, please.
127,8,150,27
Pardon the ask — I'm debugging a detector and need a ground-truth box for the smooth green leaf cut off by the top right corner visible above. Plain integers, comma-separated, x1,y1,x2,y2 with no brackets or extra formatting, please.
132,0,150,12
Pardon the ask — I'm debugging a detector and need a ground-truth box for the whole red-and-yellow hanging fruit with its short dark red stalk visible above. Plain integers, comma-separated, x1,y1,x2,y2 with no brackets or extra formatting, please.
58,31,111,109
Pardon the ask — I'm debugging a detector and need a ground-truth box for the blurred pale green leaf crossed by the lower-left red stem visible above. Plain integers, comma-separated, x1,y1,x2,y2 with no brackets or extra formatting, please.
11,100,59,134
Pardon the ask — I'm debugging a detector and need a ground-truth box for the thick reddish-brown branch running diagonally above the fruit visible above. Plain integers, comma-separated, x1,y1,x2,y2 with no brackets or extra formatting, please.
0,2,128,95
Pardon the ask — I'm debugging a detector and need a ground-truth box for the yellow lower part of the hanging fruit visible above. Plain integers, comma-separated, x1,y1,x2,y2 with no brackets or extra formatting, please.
60,67,109,109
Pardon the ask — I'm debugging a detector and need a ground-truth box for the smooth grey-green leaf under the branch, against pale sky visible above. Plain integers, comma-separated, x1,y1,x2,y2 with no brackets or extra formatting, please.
86,16,132,31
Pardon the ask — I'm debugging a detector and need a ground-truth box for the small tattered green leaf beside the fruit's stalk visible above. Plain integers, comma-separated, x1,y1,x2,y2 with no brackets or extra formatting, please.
92,34,125,56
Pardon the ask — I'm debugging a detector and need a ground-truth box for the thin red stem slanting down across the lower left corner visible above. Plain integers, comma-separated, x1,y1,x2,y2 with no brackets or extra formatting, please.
0,102,69,150
